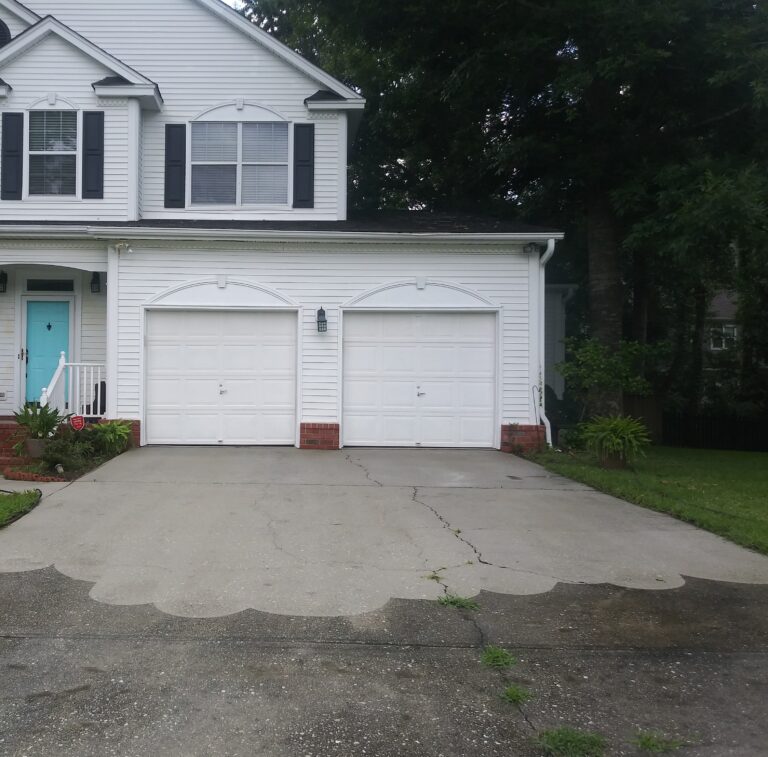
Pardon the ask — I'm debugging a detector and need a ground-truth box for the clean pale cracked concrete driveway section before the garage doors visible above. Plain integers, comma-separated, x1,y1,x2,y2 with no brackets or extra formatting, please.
0,448,768,618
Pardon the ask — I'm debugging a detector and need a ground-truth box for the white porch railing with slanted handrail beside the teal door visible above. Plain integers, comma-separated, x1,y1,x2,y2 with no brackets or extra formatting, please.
40,352,107,418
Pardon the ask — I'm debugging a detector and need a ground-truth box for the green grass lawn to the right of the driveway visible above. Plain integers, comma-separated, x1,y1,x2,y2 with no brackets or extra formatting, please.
534,447,768,554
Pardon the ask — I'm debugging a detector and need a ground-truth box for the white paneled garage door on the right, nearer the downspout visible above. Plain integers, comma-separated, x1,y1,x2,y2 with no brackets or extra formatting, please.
343,313,496,447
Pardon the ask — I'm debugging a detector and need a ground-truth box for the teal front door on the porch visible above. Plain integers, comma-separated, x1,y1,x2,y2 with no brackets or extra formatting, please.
26,300,69,402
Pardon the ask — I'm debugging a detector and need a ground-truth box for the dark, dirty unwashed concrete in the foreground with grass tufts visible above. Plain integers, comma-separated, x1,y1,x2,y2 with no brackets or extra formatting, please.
0,568,768,757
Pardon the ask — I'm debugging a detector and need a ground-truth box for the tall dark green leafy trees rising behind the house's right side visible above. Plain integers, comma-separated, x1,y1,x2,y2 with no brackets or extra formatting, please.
246,0,768,412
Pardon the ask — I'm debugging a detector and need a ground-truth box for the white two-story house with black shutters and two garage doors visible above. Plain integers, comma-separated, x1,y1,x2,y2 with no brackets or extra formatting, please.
0,0,561,448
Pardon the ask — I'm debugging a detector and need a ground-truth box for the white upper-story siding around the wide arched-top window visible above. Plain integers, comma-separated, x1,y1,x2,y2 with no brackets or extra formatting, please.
21,0,346,220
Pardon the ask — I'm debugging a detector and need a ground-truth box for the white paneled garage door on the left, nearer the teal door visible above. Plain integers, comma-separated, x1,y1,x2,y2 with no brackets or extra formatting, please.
146,311,297,444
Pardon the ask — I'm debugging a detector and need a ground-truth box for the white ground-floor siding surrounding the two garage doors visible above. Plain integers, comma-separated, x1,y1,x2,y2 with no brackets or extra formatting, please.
112,241,533,424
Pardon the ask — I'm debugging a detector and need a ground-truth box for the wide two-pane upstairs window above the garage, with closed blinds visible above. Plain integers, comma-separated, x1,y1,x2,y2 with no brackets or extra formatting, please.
191,121,288,205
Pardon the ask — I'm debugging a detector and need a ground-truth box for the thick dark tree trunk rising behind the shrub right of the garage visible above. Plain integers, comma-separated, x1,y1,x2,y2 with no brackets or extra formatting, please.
587,195,622,415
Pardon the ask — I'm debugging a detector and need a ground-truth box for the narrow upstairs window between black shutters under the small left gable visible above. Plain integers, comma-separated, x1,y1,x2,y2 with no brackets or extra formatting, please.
29,110,77,197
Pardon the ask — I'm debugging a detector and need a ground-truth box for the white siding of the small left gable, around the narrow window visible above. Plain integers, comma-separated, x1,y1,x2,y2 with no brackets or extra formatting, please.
0,36,128,221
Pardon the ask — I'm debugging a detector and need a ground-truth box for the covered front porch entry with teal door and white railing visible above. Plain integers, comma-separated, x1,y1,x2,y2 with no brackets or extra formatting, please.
0,262,108,419
